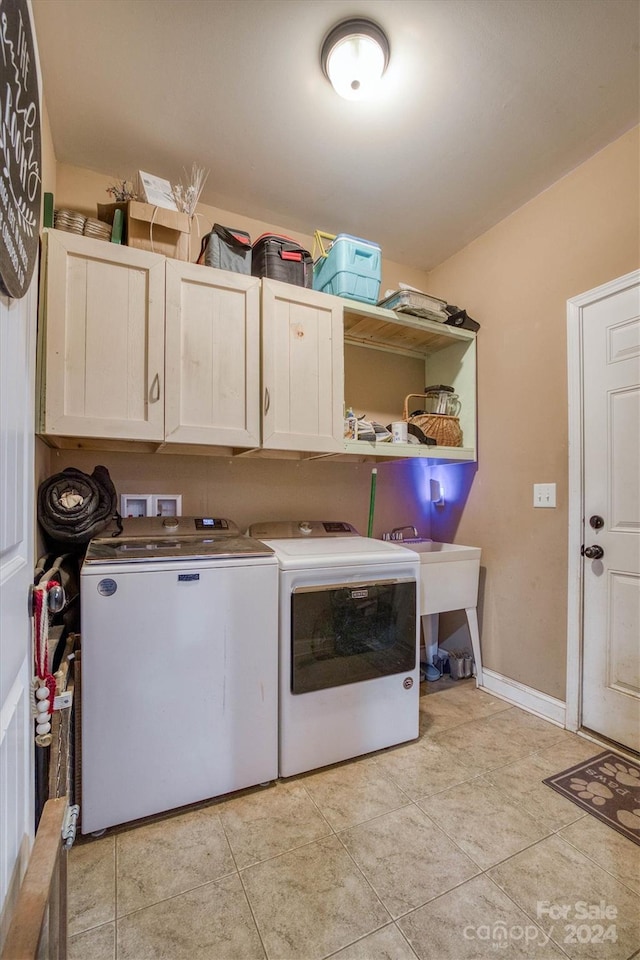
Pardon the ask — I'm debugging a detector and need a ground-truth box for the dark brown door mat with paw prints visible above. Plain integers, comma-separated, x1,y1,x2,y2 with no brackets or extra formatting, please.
542,750,640,846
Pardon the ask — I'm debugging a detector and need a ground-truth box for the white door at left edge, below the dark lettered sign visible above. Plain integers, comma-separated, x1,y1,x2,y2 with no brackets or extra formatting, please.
0,269,38,928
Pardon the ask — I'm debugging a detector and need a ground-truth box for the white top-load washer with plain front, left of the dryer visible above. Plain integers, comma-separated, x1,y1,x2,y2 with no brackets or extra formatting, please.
80,517,278,833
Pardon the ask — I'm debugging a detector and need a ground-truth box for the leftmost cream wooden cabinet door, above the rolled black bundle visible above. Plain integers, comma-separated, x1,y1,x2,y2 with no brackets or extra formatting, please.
40,230,164,441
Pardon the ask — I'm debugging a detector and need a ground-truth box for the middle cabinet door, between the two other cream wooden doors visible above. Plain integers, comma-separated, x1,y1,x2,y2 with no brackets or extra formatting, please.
165,260,260,447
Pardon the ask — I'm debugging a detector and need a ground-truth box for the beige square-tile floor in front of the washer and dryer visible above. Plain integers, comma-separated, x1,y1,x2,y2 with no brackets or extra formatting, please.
69,681,640,960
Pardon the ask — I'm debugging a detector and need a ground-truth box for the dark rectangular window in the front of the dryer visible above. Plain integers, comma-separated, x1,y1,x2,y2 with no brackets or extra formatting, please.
291,580,417,693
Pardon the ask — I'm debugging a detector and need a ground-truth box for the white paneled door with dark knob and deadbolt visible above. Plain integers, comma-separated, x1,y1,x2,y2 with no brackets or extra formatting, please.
581,274,640,750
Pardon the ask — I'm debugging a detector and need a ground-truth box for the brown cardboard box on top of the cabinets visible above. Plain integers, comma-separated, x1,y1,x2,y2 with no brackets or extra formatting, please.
98,200,191,260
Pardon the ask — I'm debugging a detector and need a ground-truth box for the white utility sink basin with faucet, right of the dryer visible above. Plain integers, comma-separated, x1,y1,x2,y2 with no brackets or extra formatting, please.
401,539,482,616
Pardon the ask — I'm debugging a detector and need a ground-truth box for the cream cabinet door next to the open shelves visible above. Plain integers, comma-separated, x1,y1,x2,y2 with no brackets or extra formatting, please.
262,280,344,453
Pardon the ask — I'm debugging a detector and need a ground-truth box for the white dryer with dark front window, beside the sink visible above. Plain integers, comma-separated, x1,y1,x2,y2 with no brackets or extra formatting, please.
248,520,420,777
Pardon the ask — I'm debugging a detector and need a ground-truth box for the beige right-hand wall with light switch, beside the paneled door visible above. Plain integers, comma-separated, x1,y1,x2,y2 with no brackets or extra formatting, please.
428,128,640,700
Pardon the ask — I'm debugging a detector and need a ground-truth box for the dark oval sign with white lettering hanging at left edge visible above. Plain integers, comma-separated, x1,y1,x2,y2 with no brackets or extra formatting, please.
0,0,42,298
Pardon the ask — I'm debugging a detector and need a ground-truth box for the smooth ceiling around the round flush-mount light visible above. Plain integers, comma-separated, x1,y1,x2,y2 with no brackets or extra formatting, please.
32,0,640,269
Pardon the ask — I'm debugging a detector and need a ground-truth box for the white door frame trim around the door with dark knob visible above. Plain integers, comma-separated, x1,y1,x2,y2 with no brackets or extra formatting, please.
566,270,640,730
